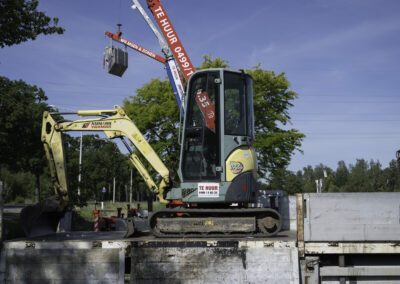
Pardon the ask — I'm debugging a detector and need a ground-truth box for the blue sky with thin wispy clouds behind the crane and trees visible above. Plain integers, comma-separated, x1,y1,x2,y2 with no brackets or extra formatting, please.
0,0,400,170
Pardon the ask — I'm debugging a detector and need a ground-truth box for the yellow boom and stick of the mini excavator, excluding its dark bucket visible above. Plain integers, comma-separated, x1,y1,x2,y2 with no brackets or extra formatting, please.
42,106,170,203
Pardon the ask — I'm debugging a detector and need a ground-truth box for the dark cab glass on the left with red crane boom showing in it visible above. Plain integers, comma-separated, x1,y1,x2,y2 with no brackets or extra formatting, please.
182,72,220,180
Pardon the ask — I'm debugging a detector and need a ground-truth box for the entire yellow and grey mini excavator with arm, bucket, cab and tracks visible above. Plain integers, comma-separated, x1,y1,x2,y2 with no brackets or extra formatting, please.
22,68,282,237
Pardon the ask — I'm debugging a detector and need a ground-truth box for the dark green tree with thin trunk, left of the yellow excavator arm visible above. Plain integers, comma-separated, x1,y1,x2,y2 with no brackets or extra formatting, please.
0,77,50,202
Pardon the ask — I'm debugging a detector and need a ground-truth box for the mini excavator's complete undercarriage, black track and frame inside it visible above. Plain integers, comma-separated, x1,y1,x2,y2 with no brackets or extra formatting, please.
149,208,282,238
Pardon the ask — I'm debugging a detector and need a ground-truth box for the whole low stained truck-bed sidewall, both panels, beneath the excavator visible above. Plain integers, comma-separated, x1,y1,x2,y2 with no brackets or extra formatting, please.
0,238,299,284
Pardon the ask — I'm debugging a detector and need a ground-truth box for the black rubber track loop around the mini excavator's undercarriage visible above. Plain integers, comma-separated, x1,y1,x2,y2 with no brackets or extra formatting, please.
149,208,282,238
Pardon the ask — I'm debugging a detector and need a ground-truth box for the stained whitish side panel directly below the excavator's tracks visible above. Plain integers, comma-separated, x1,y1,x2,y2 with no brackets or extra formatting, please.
131,240,299,284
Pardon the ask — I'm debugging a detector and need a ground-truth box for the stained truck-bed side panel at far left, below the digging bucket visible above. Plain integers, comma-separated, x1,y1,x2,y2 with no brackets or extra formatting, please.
0,241,126,284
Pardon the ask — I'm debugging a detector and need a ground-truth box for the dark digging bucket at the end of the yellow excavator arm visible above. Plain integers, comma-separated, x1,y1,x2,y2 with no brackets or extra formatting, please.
20,197,66,238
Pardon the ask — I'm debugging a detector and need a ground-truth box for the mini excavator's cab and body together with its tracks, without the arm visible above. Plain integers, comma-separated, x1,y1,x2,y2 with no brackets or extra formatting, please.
149,68,282,237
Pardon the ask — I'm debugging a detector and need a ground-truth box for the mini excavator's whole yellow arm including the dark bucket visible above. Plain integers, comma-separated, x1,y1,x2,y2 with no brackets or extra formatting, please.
21,106,170,237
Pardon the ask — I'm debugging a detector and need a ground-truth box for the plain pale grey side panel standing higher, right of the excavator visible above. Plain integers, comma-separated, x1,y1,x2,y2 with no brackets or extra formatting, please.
304,192,400,242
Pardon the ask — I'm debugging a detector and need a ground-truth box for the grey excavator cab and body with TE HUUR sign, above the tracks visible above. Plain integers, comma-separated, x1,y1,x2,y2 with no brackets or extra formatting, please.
167,69,257,204
